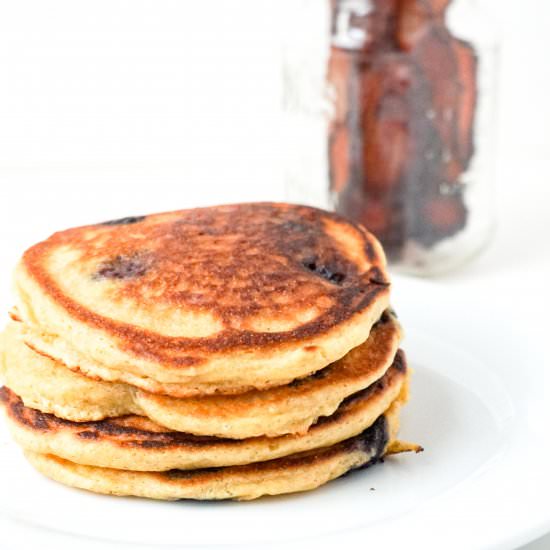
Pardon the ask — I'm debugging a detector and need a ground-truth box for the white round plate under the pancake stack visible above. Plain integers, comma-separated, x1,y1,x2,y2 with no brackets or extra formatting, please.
0,279,550,550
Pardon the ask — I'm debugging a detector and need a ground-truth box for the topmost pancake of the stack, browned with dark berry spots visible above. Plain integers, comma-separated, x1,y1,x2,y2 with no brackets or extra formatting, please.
14,203,389,397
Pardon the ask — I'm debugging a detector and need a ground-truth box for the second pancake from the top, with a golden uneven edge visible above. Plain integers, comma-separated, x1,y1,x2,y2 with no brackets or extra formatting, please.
4,312,401,439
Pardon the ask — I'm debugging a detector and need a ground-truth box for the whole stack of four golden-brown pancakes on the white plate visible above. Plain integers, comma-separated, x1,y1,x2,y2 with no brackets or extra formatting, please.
0,203,415,499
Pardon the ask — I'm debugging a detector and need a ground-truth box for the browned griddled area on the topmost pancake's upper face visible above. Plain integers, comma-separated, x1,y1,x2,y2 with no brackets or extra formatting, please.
23,203,389,367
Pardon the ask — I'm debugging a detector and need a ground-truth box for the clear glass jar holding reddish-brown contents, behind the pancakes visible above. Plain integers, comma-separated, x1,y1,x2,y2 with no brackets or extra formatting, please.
328,0,497,275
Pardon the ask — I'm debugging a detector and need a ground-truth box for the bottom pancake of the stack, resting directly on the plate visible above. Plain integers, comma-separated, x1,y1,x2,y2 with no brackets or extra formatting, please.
25,405,406,500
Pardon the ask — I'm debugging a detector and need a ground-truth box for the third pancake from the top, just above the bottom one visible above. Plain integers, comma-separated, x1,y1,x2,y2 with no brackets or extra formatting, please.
0,353,408,471
